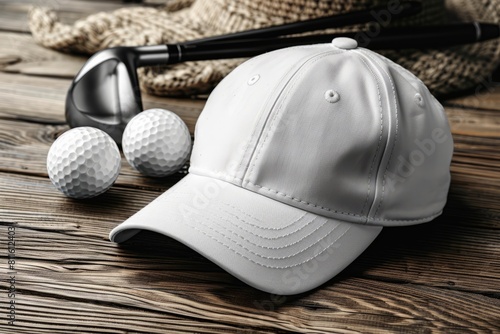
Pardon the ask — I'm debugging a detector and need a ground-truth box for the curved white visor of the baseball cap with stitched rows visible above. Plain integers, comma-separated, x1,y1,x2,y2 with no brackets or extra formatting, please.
110,174,382,295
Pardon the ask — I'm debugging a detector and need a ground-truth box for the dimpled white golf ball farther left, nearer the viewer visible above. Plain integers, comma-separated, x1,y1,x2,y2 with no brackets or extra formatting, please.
47,127,121,198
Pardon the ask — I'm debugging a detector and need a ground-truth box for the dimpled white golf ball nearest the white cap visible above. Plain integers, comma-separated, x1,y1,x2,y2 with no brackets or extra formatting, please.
122,109,191,177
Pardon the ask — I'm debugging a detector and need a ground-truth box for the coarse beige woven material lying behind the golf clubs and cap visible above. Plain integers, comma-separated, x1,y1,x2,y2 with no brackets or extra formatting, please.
30,0,500,96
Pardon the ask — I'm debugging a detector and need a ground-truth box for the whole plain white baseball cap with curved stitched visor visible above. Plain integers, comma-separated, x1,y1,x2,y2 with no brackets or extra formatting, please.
110,38,453,295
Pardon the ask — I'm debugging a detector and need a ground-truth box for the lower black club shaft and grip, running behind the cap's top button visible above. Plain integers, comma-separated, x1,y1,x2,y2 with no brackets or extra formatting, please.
167,22,500,64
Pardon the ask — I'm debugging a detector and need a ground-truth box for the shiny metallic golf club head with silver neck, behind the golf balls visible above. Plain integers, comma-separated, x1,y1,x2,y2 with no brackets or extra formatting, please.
66,45,168,144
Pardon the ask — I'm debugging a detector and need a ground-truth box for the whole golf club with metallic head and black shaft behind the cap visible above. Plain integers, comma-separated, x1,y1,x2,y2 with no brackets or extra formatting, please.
66,3,500,143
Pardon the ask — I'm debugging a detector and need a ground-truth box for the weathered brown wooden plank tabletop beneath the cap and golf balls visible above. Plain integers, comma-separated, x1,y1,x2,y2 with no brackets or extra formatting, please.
0,0,500,334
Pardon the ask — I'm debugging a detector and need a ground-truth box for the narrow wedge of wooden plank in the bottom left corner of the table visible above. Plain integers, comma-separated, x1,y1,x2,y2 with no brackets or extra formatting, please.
0,294,270,334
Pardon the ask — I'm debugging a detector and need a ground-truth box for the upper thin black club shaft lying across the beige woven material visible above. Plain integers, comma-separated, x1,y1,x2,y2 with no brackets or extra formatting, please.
184,1,422,45
